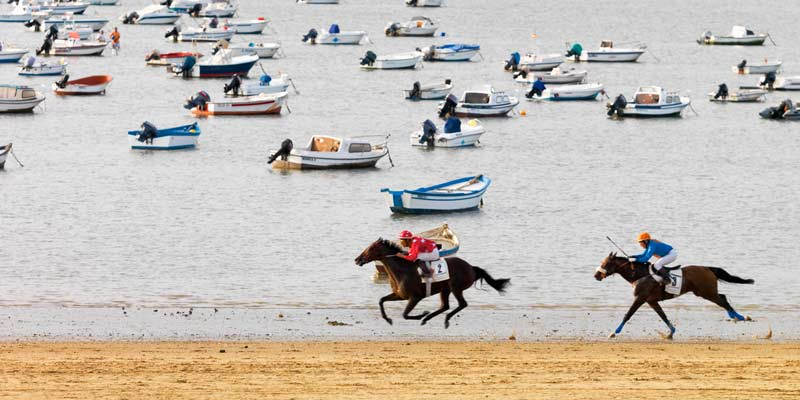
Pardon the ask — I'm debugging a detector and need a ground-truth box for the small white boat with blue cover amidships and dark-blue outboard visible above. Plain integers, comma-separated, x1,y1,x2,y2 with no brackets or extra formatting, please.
410,117,486,147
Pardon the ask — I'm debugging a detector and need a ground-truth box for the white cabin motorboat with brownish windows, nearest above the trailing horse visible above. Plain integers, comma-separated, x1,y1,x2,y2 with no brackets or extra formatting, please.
608,86,691,117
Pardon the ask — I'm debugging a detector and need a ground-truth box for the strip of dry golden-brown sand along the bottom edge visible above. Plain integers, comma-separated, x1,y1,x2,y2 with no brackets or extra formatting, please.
0,340,800,400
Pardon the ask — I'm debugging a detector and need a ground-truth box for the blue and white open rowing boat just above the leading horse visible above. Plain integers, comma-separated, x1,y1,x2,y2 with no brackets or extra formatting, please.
381,175,492,214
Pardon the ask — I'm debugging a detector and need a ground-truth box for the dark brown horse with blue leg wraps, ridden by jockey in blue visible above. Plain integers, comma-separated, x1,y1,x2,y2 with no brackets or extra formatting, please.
594,253,754,339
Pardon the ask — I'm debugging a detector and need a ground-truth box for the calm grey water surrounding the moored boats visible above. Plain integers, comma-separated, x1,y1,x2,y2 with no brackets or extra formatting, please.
0,0,800,338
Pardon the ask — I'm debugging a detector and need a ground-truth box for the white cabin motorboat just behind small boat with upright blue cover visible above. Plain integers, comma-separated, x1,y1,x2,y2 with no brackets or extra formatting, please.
439,85,519,117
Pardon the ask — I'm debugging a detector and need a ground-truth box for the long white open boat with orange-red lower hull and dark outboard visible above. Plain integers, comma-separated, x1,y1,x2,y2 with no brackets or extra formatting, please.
184,92,289,117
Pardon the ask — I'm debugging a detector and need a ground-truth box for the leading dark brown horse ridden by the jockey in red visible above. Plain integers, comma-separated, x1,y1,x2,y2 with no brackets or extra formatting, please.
355,239,509,329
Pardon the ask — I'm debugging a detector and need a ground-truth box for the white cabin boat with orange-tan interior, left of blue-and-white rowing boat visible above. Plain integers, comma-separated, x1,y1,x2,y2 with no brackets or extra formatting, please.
269,135,389,169
